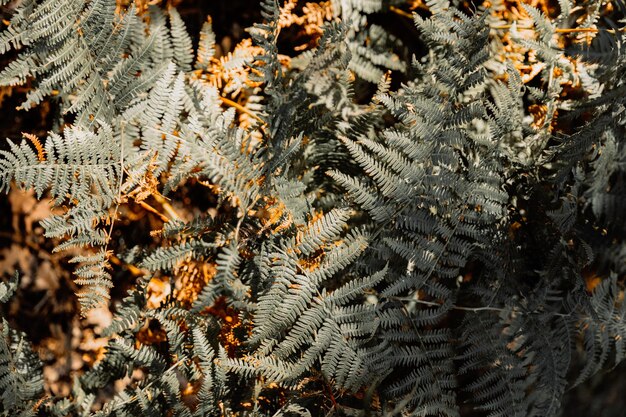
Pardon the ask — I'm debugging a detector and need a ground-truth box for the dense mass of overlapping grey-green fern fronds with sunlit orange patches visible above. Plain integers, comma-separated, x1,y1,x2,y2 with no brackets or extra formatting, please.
0,0,626,417
